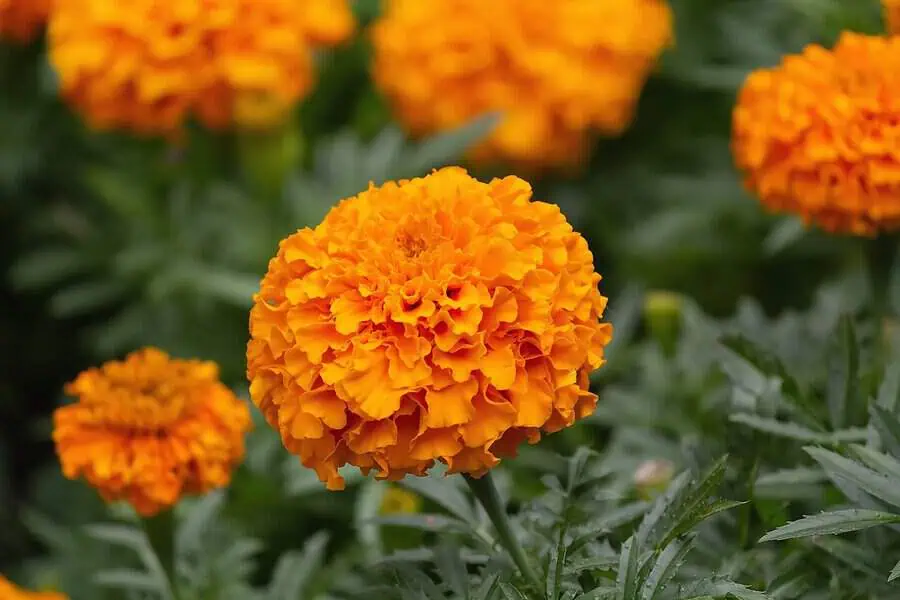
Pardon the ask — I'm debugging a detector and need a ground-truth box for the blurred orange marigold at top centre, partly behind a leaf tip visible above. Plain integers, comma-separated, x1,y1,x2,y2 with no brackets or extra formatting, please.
372,0,672,167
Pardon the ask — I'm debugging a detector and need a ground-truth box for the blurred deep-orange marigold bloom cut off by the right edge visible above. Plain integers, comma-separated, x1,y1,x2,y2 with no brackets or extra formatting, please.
733,33,900,235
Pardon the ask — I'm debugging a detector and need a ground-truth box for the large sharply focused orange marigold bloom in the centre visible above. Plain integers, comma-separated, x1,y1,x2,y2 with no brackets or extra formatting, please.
247,167,612,489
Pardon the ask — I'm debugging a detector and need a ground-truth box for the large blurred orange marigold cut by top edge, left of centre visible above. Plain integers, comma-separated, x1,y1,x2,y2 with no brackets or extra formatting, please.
47,0,354,134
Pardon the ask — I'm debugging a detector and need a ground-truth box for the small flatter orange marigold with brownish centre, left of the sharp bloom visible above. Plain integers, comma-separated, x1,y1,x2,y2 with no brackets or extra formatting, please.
53,348,251,516
